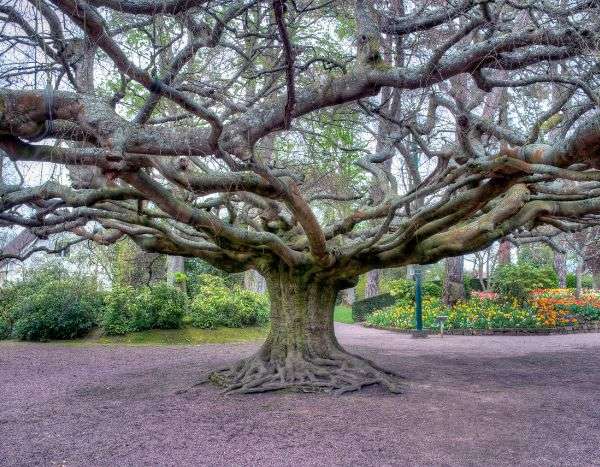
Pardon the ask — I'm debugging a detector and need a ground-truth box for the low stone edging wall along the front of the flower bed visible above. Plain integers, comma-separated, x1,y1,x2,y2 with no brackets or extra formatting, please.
362,322,600,336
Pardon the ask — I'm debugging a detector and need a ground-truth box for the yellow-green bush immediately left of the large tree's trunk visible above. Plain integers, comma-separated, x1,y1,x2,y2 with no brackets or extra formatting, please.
190,274,269,329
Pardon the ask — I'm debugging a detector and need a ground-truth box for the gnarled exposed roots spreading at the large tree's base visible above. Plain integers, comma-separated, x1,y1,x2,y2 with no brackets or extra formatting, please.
209,351,401,394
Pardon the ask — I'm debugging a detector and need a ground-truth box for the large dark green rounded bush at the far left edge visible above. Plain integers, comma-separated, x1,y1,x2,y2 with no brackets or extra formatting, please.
0,265,103,341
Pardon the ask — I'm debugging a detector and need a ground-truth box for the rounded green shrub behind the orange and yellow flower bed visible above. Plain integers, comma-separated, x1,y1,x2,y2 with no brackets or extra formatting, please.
492,261,558,303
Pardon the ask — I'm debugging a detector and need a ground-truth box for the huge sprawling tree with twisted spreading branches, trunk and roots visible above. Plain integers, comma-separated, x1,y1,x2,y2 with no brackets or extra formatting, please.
0,0,600,392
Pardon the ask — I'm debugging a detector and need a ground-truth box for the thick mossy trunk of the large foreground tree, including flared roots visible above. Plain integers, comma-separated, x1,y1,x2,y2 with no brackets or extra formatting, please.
210,272,399,393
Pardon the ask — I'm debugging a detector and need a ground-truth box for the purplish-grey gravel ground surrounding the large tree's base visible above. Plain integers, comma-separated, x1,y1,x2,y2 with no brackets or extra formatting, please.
0,324,600,466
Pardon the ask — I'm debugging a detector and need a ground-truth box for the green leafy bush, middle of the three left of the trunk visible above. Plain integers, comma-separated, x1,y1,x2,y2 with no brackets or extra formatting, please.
100,283,187,335
